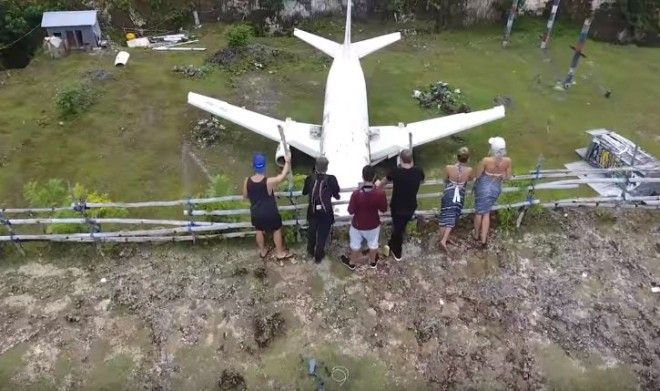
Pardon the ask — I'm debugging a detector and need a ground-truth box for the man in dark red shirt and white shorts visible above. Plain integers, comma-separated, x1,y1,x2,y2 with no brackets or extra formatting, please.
341,166,387,270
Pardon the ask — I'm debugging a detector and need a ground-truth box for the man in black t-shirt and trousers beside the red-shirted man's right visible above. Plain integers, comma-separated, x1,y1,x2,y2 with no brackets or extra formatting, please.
379,149,424,261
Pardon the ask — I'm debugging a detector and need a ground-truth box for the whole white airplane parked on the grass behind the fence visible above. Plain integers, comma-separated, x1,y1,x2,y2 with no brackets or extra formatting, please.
188,0,505,216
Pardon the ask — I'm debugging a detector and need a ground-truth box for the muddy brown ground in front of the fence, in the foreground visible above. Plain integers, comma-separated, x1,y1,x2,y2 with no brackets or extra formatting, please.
0,211,660,390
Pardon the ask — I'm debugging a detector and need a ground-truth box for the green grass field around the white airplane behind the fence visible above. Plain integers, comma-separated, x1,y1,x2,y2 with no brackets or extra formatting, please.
0,19,660,210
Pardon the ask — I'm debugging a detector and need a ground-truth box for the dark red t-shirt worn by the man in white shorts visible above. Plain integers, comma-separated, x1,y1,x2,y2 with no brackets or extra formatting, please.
348,185,387,231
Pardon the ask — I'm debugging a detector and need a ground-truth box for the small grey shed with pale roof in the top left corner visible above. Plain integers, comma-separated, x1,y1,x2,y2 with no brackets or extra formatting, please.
41,10,101,50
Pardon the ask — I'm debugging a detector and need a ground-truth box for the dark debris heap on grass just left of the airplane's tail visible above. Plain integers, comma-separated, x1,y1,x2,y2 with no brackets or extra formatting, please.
206,44,294,74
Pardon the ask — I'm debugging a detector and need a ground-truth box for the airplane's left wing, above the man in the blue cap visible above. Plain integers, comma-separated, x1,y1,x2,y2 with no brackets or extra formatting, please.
188,92,321,158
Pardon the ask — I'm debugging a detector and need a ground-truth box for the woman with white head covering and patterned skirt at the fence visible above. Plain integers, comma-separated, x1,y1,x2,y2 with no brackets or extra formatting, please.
473,137,511,246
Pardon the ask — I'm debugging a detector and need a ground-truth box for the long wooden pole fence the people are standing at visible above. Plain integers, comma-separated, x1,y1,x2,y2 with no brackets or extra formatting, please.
0,167,660,244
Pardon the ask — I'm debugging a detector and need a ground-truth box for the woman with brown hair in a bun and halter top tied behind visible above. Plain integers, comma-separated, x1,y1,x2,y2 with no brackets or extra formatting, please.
440,147,472,252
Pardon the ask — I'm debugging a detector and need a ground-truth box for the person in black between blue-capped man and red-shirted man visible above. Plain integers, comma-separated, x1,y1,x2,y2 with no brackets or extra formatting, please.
303,156,339,263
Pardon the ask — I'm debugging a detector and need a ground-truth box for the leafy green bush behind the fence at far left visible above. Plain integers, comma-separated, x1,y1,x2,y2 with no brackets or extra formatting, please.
23,179,128,234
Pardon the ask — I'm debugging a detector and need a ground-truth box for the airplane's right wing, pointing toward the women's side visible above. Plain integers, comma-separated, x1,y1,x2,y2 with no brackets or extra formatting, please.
369,106,504,163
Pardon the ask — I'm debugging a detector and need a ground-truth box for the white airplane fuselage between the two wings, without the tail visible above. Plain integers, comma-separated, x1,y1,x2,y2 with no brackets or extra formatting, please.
321,46,371,213
